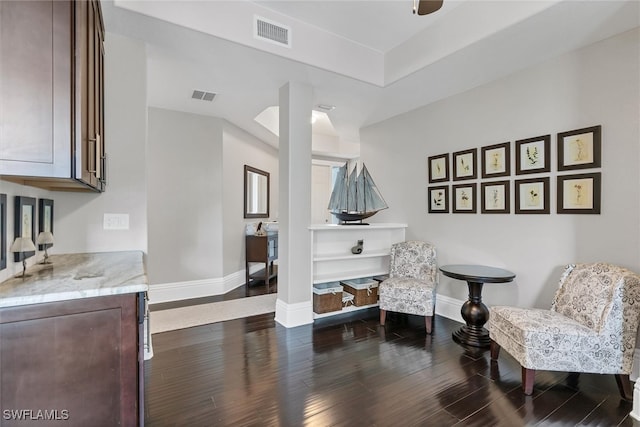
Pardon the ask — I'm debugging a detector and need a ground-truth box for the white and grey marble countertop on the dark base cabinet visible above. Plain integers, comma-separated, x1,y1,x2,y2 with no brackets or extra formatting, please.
0,251,149,307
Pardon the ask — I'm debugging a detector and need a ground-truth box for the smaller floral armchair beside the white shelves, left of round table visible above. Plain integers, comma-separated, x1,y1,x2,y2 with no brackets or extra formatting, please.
378,241,438,334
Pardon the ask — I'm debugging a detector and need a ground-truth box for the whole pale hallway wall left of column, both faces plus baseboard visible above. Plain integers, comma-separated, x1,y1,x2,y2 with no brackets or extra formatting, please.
147,107,278,303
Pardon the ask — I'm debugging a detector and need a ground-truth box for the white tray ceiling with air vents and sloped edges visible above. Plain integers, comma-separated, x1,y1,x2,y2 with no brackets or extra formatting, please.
102,0,640,155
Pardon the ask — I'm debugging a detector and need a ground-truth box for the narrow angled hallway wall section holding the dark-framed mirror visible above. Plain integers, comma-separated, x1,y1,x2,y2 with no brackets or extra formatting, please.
222,121,279,276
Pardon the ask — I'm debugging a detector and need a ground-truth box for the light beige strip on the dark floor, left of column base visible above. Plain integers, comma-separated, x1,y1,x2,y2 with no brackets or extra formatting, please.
149,294,278,334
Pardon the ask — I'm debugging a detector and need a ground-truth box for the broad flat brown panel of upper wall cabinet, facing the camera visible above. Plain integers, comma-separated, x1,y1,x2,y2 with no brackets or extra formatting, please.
0,1,72,178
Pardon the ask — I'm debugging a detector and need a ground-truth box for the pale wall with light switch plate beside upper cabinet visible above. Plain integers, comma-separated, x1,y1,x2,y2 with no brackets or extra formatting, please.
51,33,147,253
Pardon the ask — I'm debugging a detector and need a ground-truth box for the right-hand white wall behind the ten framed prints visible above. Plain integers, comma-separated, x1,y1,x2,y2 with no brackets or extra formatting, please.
361,29,640,307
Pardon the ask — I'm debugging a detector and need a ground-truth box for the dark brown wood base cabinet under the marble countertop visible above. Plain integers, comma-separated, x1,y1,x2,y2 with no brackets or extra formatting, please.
0,294,144,427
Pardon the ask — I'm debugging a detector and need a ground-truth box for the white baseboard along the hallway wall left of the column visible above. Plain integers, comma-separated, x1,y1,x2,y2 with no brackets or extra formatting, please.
149,270,245,305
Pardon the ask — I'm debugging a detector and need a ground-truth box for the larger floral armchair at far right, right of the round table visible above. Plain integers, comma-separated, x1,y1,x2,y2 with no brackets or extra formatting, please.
487,263,640,399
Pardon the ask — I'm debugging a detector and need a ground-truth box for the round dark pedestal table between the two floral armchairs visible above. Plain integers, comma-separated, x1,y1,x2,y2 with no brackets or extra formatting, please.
440,265,516,347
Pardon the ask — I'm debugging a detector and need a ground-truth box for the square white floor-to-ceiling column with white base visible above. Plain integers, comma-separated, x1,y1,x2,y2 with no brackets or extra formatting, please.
275,82,313,328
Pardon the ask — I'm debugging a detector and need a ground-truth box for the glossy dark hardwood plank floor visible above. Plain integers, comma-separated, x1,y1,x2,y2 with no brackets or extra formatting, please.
145,287,634,426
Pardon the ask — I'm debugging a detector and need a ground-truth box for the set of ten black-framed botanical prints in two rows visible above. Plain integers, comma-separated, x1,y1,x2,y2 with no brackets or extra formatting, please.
427,125,602,215
